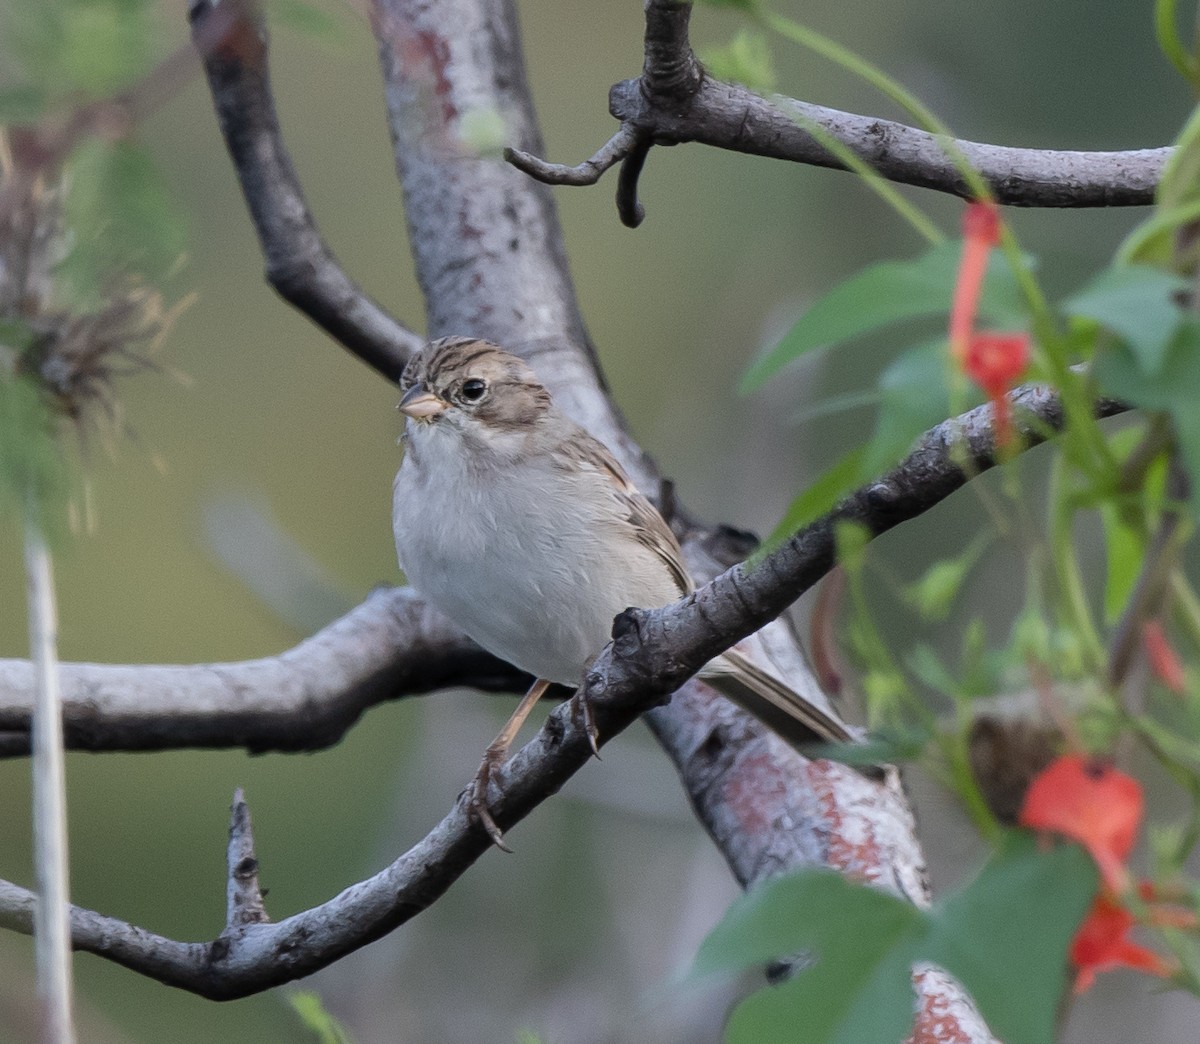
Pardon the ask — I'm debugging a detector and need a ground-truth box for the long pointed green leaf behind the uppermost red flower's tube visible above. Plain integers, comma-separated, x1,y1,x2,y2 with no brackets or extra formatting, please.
742,240,1026,392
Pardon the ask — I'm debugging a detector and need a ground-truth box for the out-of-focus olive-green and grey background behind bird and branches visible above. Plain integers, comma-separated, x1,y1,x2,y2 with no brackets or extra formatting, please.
0,0,1196,1044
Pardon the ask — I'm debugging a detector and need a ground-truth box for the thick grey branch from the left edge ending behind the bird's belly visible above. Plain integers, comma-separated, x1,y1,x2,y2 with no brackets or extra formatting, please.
0,588,528,756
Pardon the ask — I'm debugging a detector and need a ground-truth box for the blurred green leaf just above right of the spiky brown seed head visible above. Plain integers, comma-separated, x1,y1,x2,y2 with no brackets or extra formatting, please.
60,139,186,301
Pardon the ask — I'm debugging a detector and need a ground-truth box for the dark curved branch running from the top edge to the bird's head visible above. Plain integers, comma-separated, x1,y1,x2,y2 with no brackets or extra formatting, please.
188,0,424,380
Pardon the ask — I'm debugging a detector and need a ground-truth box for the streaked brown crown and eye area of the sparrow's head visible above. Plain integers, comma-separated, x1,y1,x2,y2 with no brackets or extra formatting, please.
400,337,550,430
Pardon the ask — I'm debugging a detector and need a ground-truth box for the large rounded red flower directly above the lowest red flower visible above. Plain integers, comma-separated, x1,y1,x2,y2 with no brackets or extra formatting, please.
1020,754,1142,892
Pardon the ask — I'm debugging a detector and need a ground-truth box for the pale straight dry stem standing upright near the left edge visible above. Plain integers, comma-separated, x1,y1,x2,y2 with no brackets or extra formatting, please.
25,523,74,1044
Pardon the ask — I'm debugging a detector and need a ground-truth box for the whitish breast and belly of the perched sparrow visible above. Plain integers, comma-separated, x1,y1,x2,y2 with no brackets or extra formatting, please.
394,426,677,685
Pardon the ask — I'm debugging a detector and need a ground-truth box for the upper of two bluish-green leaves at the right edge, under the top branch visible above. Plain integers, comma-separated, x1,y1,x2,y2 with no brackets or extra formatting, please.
1063,265,1188,373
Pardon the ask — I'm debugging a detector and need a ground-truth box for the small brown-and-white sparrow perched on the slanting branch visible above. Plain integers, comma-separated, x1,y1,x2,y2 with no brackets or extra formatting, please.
392,337,852,848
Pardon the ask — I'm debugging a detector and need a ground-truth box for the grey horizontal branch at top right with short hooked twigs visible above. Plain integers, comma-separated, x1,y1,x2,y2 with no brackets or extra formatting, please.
512,0,1171,217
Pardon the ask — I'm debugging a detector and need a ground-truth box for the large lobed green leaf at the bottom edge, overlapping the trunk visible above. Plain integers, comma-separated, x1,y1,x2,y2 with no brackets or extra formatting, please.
691,833,1097,1044
